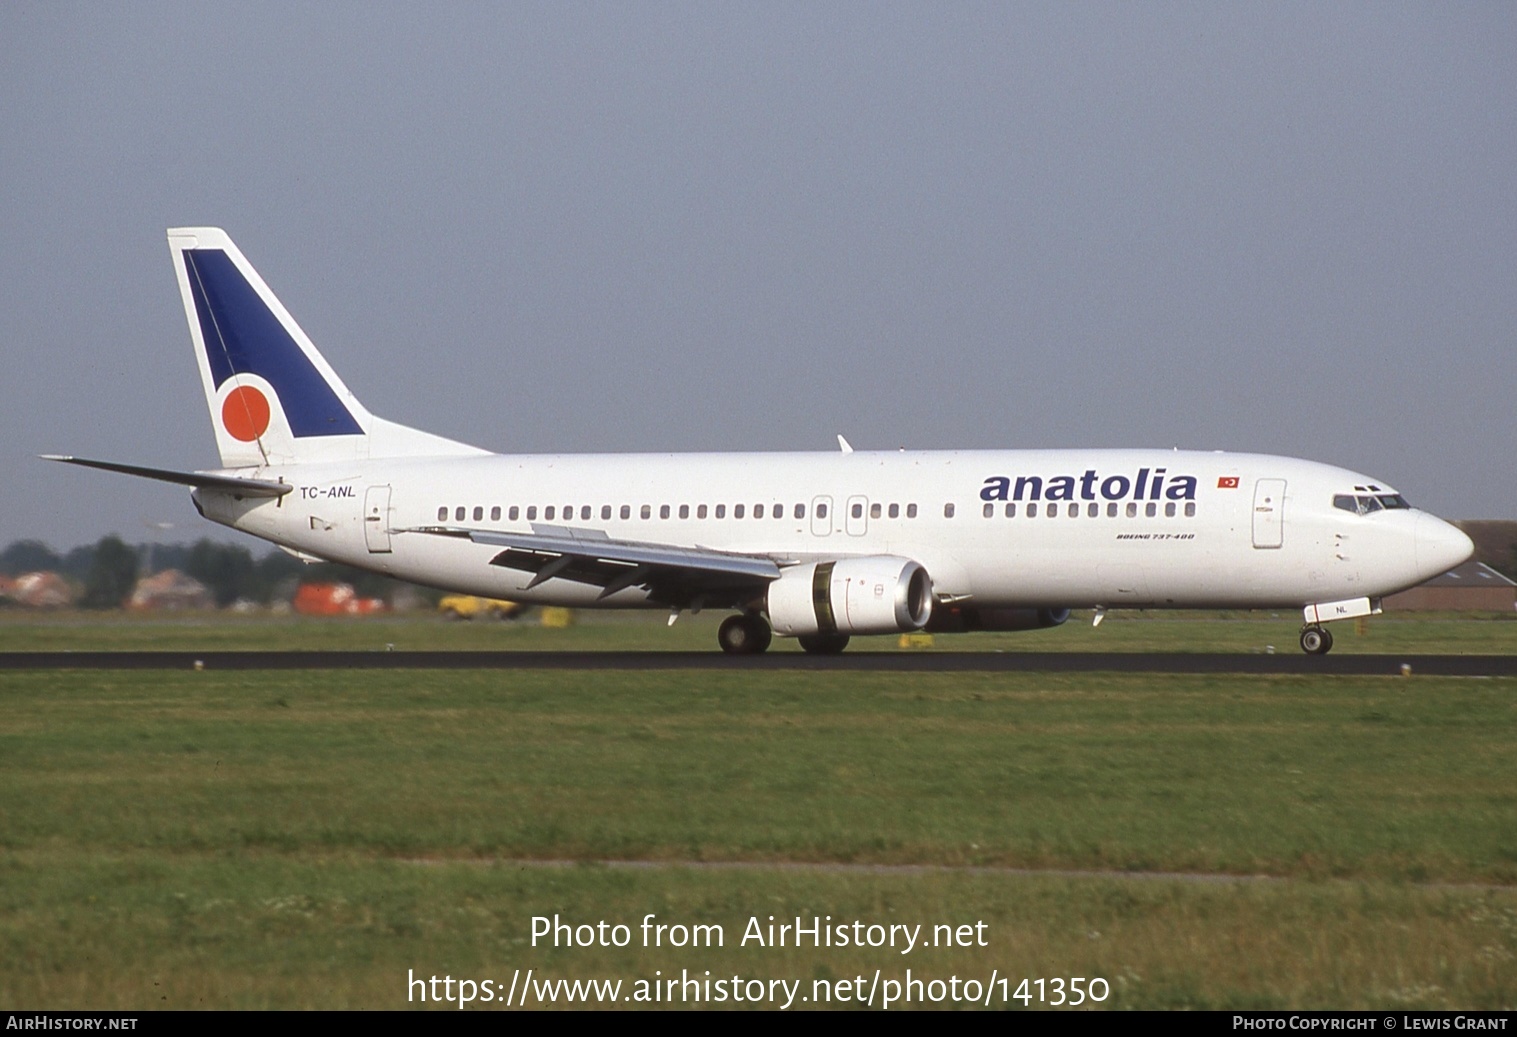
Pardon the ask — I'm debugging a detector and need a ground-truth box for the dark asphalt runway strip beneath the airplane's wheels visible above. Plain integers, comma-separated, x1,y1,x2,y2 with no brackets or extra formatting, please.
0,652,1517,676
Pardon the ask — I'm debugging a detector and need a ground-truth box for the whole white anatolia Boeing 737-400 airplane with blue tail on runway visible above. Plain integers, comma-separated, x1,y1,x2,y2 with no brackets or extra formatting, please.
44,227,1475,655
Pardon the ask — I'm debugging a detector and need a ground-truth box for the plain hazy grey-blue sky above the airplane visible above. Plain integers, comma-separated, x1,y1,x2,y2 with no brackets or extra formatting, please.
0,3,1517,547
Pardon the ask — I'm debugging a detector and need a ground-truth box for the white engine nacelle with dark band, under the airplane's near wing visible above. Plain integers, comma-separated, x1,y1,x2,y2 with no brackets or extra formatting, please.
766,555,933,637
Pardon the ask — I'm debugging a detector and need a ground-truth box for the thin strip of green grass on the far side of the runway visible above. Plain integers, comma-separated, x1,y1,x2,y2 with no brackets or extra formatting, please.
0,611,1517,655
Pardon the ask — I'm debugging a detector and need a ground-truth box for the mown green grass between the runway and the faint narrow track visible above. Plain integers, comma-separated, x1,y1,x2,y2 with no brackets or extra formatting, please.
0,672,1517,882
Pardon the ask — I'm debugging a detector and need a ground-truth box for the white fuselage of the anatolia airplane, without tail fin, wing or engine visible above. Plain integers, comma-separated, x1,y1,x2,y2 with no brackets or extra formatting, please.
196,450,1468,608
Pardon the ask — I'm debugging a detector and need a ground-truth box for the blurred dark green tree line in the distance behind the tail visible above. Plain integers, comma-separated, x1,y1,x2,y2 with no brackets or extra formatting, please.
0,535,437,608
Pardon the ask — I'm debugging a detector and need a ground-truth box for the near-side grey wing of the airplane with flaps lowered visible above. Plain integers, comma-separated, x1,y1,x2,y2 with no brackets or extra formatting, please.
416,526,780,606
